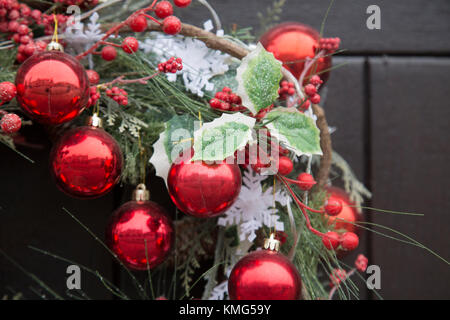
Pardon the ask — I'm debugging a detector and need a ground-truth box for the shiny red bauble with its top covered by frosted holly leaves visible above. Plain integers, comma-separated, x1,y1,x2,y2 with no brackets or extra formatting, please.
167,150,242,218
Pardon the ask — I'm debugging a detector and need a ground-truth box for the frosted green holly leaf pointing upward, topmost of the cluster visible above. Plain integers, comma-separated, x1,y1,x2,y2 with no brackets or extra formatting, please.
236,43,283,114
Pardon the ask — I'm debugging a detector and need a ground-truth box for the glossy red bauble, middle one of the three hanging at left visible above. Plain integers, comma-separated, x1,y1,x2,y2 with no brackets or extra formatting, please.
50,126,123,198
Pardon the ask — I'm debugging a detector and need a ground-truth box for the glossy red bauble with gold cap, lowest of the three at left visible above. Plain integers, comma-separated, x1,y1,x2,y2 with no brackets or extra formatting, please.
106,201,175,270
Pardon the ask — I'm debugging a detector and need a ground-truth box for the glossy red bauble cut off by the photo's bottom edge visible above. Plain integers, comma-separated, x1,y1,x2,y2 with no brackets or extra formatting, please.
228,250,302,300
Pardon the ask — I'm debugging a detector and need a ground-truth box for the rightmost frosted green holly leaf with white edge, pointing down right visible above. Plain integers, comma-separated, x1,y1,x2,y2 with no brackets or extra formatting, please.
264,108,322,156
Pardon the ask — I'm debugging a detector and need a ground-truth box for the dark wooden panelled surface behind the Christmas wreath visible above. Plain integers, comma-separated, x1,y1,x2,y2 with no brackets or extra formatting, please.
0,0,450,299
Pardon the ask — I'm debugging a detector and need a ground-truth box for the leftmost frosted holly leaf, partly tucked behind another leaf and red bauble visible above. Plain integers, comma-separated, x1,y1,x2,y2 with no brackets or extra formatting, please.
150,114,195,185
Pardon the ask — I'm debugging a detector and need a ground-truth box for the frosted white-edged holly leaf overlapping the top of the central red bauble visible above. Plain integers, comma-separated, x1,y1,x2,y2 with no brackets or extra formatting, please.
192,112,256,161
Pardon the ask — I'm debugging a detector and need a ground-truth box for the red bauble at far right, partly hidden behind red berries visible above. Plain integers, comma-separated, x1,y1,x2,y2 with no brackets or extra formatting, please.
325,187,362,233
